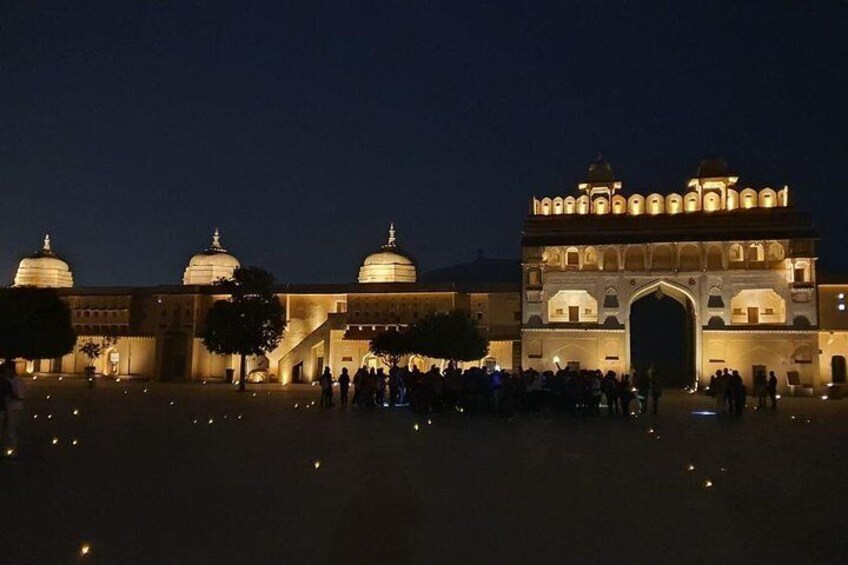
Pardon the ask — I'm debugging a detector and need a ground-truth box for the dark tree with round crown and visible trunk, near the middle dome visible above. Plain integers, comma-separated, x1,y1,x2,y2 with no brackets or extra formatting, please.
203,267,285,392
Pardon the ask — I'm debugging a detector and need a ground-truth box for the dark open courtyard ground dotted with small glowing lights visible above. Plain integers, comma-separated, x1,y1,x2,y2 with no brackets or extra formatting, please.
0,380,848,565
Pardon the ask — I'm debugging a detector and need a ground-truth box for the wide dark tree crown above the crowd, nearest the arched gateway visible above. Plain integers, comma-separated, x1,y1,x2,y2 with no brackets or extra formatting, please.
409,310,489,364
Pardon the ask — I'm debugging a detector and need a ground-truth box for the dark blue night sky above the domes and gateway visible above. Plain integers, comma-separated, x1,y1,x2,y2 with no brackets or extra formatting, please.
0,0,848,285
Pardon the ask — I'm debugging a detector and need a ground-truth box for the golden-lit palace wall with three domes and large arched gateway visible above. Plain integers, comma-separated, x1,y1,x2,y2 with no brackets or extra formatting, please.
6,158,848,393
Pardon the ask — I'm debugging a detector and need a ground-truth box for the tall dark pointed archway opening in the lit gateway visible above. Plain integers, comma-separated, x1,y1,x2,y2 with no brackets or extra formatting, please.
629,285,696,388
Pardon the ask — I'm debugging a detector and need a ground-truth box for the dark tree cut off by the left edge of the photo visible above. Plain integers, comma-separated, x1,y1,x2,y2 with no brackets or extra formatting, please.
0,287,77,362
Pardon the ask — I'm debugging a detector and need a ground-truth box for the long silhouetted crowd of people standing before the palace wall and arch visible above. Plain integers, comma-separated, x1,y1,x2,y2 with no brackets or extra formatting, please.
318,364,663,417
